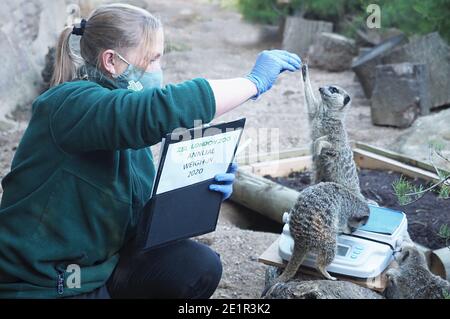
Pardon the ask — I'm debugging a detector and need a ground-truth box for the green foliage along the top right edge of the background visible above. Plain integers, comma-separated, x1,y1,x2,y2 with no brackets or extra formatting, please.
238,0,450,43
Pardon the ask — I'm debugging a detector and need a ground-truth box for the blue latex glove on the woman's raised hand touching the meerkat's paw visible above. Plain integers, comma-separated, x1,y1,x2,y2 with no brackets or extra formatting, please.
247,50,302,99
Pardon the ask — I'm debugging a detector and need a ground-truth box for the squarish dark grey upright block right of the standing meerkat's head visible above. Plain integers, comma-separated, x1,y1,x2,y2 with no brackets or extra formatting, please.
371,63,430,128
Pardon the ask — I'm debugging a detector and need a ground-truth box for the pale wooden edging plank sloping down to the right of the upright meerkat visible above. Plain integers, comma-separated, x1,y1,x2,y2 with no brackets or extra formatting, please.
353,148,439,183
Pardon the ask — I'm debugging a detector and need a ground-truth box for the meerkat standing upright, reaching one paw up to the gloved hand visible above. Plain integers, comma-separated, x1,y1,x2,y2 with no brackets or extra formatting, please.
302,64,362,196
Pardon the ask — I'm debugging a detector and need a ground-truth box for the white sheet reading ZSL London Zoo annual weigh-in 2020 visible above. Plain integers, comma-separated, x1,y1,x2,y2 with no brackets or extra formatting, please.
156,130,241,194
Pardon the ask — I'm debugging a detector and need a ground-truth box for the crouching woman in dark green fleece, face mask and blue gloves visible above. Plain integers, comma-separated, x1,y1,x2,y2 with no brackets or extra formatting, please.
0,4,301,298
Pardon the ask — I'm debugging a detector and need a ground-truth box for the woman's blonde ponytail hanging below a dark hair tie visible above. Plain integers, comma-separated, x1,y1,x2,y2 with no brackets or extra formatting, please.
50,27,83,87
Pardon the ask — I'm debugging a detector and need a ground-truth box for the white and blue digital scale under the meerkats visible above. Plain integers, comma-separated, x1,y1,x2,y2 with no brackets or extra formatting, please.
278,205,408,278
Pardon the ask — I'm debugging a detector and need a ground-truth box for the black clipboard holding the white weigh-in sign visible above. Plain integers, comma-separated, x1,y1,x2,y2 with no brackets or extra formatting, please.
136,118,245,249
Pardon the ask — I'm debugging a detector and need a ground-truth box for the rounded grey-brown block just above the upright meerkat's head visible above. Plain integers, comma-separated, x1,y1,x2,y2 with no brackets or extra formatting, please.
308,32,357,72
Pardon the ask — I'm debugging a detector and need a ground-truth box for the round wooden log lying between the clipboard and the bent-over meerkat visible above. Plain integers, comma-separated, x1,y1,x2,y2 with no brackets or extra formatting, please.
231,169,299,223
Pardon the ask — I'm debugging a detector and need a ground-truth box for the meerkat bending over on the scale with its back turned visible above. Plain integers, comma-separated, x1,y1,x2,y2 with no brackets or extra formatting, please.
277,182,369,282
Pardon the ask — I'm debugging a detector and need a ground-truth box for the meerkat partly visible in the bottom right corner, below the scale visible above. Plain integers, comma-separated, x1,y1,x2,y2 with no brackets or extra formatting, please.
386,245,450,299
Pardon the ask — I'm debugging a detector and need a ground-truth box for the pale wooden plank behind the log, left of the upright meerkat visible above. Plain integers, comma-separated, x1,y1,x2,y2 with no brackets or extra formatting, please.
251,156,312,176
